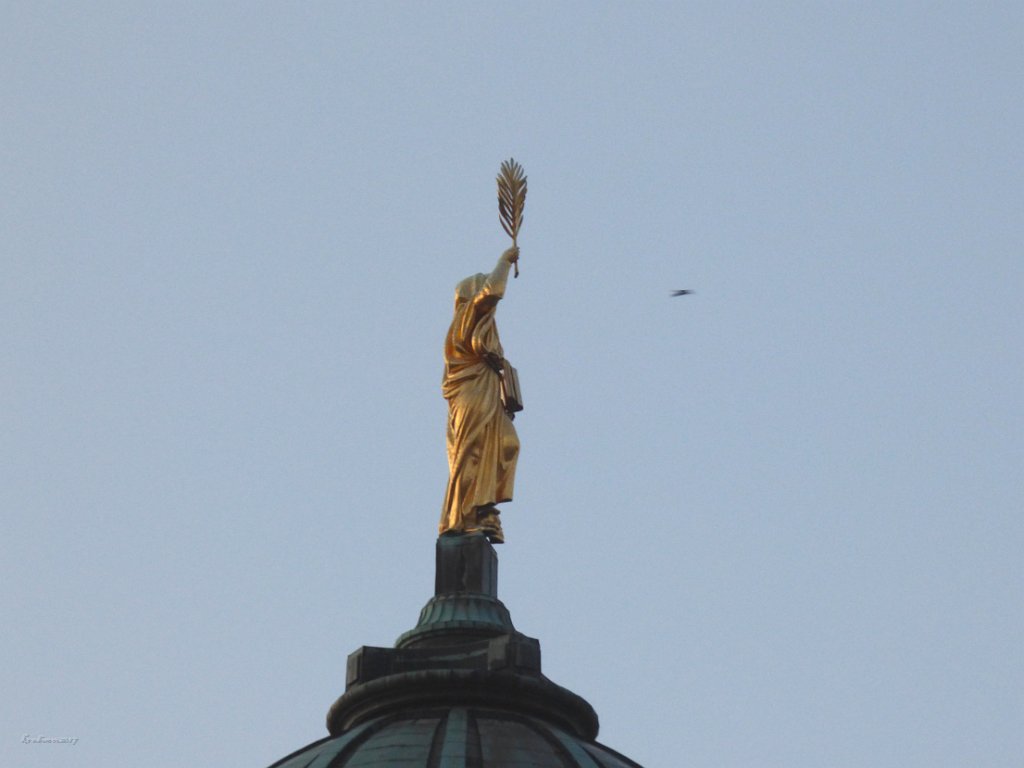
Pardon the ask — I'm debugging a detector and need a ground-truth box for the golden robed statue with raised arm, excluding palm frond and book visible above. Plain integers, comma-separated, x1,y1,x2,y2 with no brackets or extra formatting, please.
439,247,519,544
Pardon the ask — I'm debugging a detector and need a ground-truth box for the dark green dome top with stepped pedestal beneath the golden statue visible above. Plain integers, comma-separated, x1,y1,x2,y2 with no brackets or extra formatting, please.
271,536,640,768
